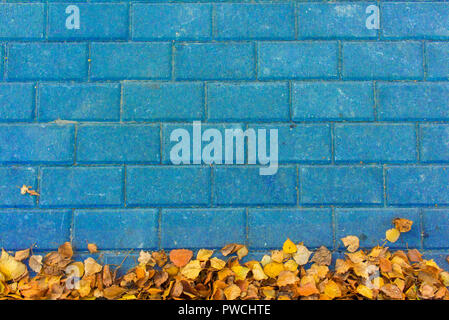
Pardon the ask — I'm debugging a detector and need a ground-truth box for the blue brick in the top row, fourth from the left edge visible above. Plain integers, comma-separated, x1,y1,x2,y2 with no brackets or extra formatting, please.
214,3,295,40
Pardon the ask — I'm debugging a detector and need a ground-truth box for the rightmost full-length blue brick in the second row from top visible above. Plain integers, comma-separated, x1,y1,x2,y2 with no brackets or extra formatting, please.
342,42,424,80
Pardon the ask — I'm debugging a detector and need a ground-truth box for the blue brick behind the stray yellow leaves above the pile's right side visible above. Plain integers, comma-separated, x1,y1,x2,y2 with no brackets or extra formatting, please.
335,208,421,249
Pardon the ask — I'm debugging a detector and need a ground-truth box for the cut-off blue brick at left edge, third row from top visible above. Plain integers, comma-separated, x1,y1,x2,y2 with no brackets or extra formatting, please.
0,83,34,122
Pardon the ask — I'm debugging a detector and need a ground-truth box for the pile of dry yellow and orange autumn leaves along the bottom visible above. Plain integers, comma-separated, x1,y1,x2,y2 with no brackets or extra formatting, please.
0,219,449,300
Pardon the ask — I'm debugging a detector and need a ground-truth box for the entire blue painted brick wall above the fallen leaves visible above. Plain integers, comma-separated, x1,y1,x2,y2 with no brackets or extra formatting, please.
0,0,449,268
